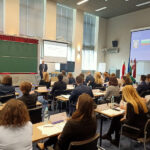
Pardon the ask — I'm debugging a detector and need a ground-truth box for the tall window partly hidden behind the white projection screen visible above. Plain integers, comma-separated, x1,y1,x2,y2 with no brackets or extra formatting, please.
55,4,75,70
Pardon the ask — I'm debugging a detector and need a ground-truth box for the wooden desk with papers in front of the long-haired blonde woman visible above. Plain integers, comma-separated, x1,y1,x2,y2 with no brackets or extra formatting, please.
95,104,125,146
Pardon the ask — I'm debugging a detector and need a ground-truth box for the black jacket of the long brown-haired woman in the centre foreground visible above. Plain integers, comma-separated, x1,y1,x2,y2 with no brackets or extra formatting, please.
55,118,97,150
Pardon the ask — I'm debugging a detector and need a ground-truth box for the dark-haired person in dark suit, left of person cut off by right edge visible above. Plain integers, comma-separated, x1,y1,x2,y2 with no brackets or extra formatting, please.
136,75,148,95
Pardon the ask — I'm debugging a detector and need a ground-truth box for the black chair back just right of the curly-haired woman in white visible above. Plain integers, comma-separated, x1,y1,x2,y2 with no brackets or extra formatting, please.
28,106,42,124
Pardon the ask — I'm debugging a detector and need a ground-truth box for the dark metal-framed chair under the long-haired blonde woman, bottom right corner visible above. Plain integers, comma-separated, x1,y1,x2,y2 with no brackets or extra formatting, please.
119,119,150,150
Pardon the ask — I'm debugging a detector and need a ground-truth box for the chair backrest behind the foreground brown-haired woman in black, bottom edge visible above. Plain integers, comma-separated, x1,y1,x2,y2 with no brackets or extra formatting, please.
68,134,99,150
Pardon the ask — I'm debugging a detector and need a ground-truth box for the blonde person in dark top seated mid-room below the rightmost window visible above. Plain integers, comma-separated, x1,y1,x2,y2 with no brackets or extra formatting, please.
89,72,103,89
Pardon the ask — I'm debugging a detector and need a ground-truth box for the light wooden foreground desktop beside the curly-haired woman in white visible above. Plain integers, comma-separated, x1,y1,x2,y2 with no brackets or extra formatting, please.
32,122,63,142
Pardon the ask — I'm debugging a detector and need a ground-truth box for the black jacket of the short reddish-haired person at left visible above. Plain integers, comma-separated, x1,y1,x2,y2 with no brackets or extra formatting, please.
18,94,37,109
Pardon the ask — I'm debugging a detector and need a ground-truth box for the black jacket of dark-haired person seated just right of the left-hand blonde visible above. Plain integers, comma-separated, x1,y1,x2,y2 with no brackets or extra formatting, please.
51,81,67,94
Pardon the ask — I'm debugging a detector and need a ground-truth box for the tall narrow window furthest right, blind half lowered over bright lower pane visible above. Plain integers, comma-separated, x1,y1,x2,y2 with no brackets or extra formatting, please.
82,13,96,70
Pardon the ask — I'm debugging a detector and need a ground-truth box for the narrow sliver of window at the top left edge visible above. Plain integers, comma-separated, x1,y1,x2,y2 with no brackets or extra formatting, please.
0,0,4,32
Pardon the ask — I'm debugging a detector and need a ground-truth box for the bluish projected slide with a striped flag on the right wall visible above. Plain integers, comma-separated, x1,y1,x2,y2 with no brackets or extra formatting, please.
130,29,150,61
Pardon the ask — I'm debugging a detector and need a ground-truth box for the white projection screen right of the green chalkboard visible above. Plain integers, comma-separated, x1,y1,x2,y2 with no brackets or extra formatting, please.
44,41,68,63
